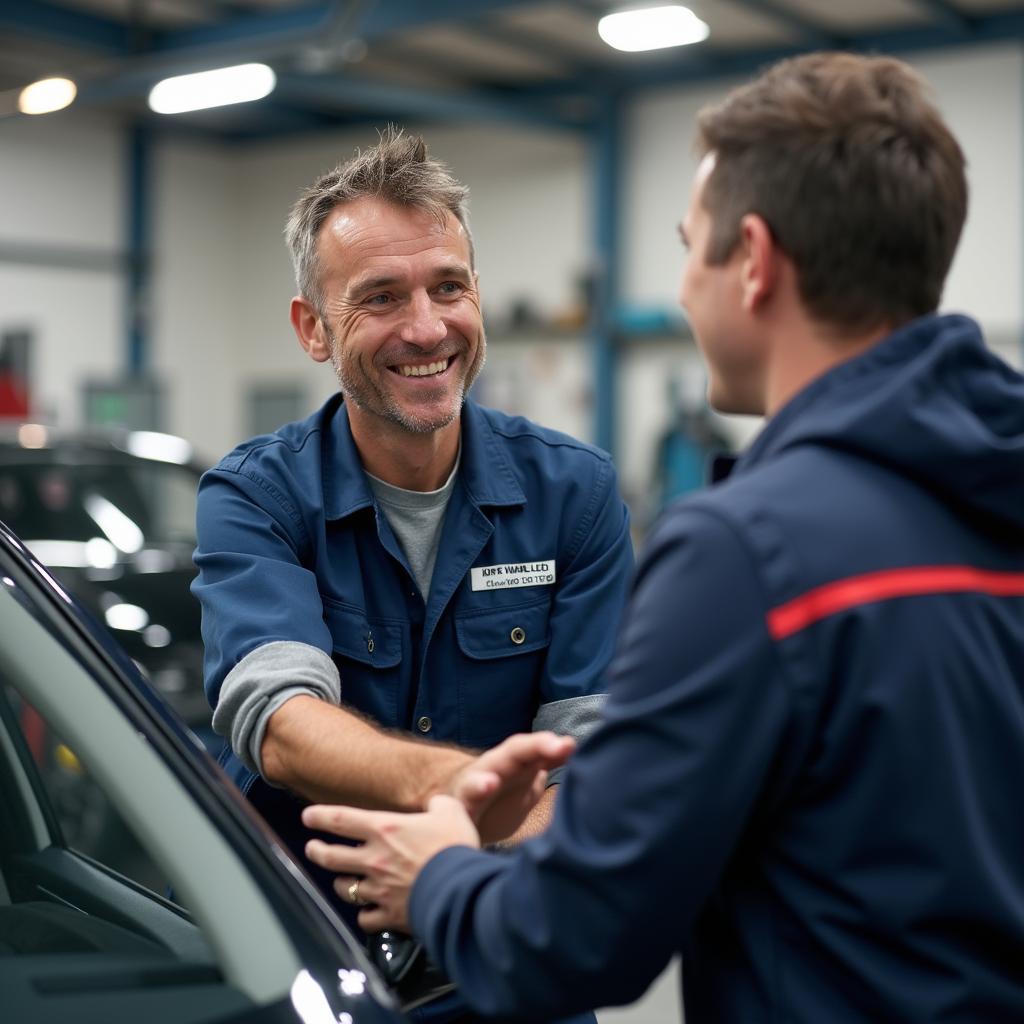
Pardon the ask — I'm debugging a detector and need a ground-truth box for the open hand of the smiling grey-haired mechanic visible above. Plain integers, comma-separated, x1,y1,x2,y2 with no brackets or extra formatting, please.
447,732,575,844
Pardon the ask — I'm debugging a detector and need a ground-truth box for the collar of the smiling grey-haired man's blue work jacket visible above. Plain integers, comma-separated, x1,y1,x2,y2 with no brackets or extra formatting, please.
323,395,526,519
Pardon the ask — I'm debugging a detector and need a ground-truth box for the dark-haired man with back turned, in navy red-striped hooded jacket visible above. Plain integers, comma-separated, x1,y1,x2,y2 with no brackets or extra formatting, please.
305,53,1024,1024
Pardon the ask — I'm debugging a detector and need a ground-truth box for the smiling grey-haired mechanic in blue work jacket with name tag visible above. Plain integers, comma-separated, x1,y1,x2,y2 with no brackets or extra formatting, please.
188,130,633,1020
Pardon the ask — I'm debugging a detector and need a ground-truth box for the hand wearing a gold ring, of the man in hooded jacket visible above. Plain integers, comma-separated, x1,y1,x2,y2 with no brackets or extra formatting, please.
302,790,475,932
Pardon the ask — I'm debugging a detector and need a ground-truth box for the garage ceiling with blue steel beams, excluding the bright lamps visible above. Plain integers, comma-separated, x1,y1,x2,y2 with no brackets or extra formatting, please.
0,0,1024,138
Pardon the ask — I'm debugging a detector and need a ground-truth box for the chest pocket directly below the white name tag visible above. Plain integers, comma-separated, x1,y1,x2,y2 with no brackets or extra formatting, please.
455,596,551,746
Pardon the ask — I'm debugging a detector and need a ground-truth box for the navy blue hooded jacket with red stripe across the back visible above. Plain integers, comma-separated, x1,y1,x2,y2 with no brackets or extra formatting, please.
411,316,1024,1024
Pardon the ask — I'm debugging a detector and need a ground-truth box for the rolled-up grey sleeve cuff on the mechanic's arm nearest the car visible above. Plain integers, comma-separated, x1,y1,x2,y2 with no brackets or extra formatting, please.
213,640,341,775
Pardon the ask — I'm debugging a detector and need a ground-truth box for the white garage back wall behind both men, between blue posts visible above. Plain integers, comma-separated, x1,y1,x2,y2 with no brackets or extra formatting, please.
6,44,1024,468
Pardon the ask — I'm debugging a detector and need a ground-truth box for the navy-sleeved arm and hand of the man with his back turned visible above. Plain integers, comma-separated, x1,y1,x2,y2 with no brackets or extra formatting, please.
299,510,795,1019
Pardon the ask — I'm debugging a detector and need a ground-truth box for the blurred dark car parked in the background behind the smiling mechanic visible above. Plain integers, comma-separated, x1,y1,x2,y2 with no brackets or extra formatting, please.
0,423,209,741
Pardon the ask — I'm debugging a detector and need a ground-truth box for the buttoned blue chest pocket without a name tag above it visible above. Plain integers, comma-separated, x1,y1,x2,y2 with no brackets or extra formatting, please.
324,600,402,728
